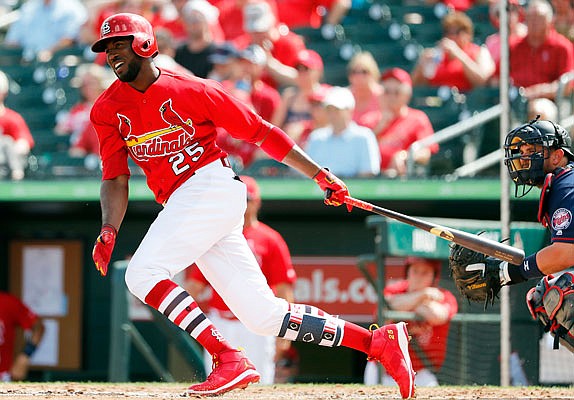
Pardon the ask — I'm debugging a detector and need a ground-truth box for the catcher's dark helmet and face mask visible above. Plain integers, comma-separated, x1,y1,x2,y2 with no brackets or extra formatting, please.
504,116,574,197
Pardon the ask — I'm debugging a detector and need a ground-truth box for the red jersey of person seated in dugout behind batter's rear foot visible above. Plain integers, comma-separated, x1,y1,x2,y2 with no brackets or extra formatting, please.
384,280,458,371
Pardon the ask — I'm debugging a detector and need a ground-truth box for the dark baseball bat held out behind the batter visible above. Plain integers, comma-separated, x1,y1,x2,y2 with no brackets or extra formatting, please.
345,196,524,264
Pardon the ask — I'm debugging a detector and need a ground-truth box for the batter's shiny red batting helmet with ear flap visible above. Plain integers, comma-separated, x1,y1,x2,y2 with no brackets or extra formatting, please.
92,13,158,58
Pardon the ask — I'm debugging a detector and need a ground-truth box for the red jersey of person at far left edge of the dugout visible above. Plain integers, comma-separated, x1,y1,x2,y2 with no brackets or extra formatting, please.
0,292,38,373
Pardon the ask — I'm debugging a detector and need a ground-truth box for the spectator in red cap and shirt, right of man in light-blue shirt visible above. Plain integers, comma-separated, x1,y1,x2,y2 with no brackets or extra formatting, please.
367,68,438,177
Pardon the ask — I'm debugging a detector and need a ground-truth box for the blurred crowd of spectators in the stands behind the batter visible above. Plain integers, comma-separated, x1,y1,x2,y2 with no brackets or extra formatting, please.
0,0,574,179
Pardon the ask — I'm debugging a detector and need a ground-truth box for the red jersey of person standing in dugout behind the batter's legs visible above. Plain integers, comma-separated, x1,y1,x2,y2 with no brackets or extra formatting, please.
186,222,297,316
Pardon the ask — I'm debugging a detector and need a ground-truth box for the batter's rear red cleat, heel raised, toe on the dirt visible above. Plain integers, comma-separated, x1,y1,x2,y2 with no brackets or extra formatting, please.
369,322,415,399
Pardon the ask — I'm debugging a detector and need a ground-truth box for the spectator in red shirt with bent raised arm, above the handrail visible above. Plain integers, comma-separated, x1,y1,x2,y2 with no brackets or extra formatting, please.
412,12,495,91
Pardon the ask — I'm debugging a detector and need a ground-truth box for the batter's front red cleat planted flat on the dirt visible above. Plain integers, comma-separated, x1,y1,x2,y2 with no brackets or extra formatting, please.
186,349,261,396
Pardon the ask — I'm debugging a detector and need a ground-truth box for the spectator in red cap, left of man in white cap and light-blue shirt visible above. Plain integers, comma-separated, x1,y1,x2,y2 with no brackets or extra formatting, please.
271,50,330,142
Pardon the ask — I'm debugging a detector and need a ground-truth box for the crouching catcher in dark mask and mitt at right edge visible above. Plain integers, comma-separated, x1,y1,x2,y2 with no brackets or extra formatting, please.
449,117,574,352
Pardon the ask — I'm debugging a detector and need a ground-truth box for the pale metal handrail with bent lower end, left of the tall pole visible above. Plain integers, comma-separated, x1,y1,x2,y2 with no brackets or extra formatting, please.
407,104,502,177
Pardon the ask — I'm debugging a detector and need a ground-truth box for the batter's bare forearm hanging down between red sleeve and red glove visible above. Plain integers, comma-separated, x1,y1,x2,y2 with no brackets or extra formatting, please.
100,175,129,230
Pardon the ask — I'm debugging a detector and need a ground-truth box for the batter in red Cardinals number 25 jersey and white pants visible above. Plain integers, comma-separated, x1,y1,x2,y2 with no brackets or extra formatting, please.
91,13,414,398
